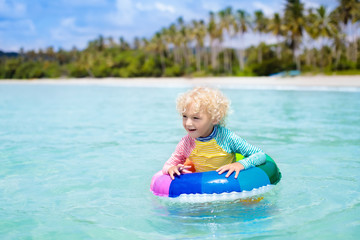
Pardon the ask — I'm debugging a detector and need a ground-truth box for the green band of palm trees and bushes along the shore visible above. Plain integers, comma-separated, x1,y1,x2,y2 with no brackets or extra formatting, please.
0,0,360,79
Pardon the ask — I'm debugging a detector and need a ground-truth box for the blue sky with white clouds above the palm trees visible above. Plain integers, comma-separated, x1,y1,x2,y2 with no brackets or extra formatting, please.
0,0,337,51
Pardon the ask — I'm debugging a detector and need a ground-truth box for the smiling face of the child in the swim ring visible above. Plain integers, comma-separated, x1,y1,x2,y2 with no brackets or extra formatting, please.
183,105,216,138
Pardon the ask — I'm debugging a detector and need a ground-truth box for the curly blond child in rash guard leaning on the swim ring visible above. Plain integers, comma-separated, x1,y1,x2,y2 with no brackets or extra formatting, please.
162,87,266,179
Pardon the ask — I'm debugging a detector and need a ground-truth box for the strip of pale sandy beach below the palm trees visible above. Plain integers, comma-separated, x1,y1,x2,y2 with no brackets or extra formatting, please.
0,75,360,91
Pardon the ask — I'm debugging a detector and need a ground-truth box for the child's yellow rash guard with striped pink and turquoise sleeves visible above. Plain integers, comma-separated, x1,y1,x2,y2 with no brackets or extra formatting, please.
162,125,266,174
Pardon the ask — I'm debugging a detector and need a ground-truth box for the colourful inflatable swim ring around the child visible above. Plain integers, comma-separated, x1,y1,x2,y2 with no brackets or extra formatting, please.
150,155,281,198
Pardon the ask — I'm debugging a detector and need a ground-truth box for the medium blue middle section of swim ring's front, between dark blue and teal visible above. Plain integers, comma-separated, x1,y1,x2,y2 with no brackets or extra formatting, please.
201,171,240,194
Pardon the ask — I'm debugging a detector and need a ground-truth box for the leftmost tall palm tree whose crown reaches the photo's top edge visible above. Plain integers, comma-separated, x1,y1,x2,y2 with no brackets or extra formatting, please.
284,0,305,70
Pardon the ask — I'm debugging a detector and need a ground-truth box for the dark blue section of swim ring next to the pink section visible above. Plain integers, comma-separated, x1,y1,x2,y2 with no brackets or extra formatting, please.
169,173,203,197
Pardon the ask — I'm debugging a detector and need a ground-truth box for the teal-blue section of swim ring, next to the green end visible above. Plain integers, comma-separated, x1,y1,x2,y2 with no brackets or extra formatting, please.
238,167,270,191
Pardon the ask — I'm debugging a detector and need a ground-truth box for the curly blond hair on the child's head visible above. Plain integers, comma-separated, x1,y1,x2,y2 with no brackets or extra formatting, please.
176,87,230,125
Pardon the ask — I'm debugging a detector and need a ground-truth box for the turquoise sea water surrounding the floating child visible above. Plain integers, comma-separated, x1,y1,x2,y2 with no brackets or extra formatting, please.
0,81,360,239
